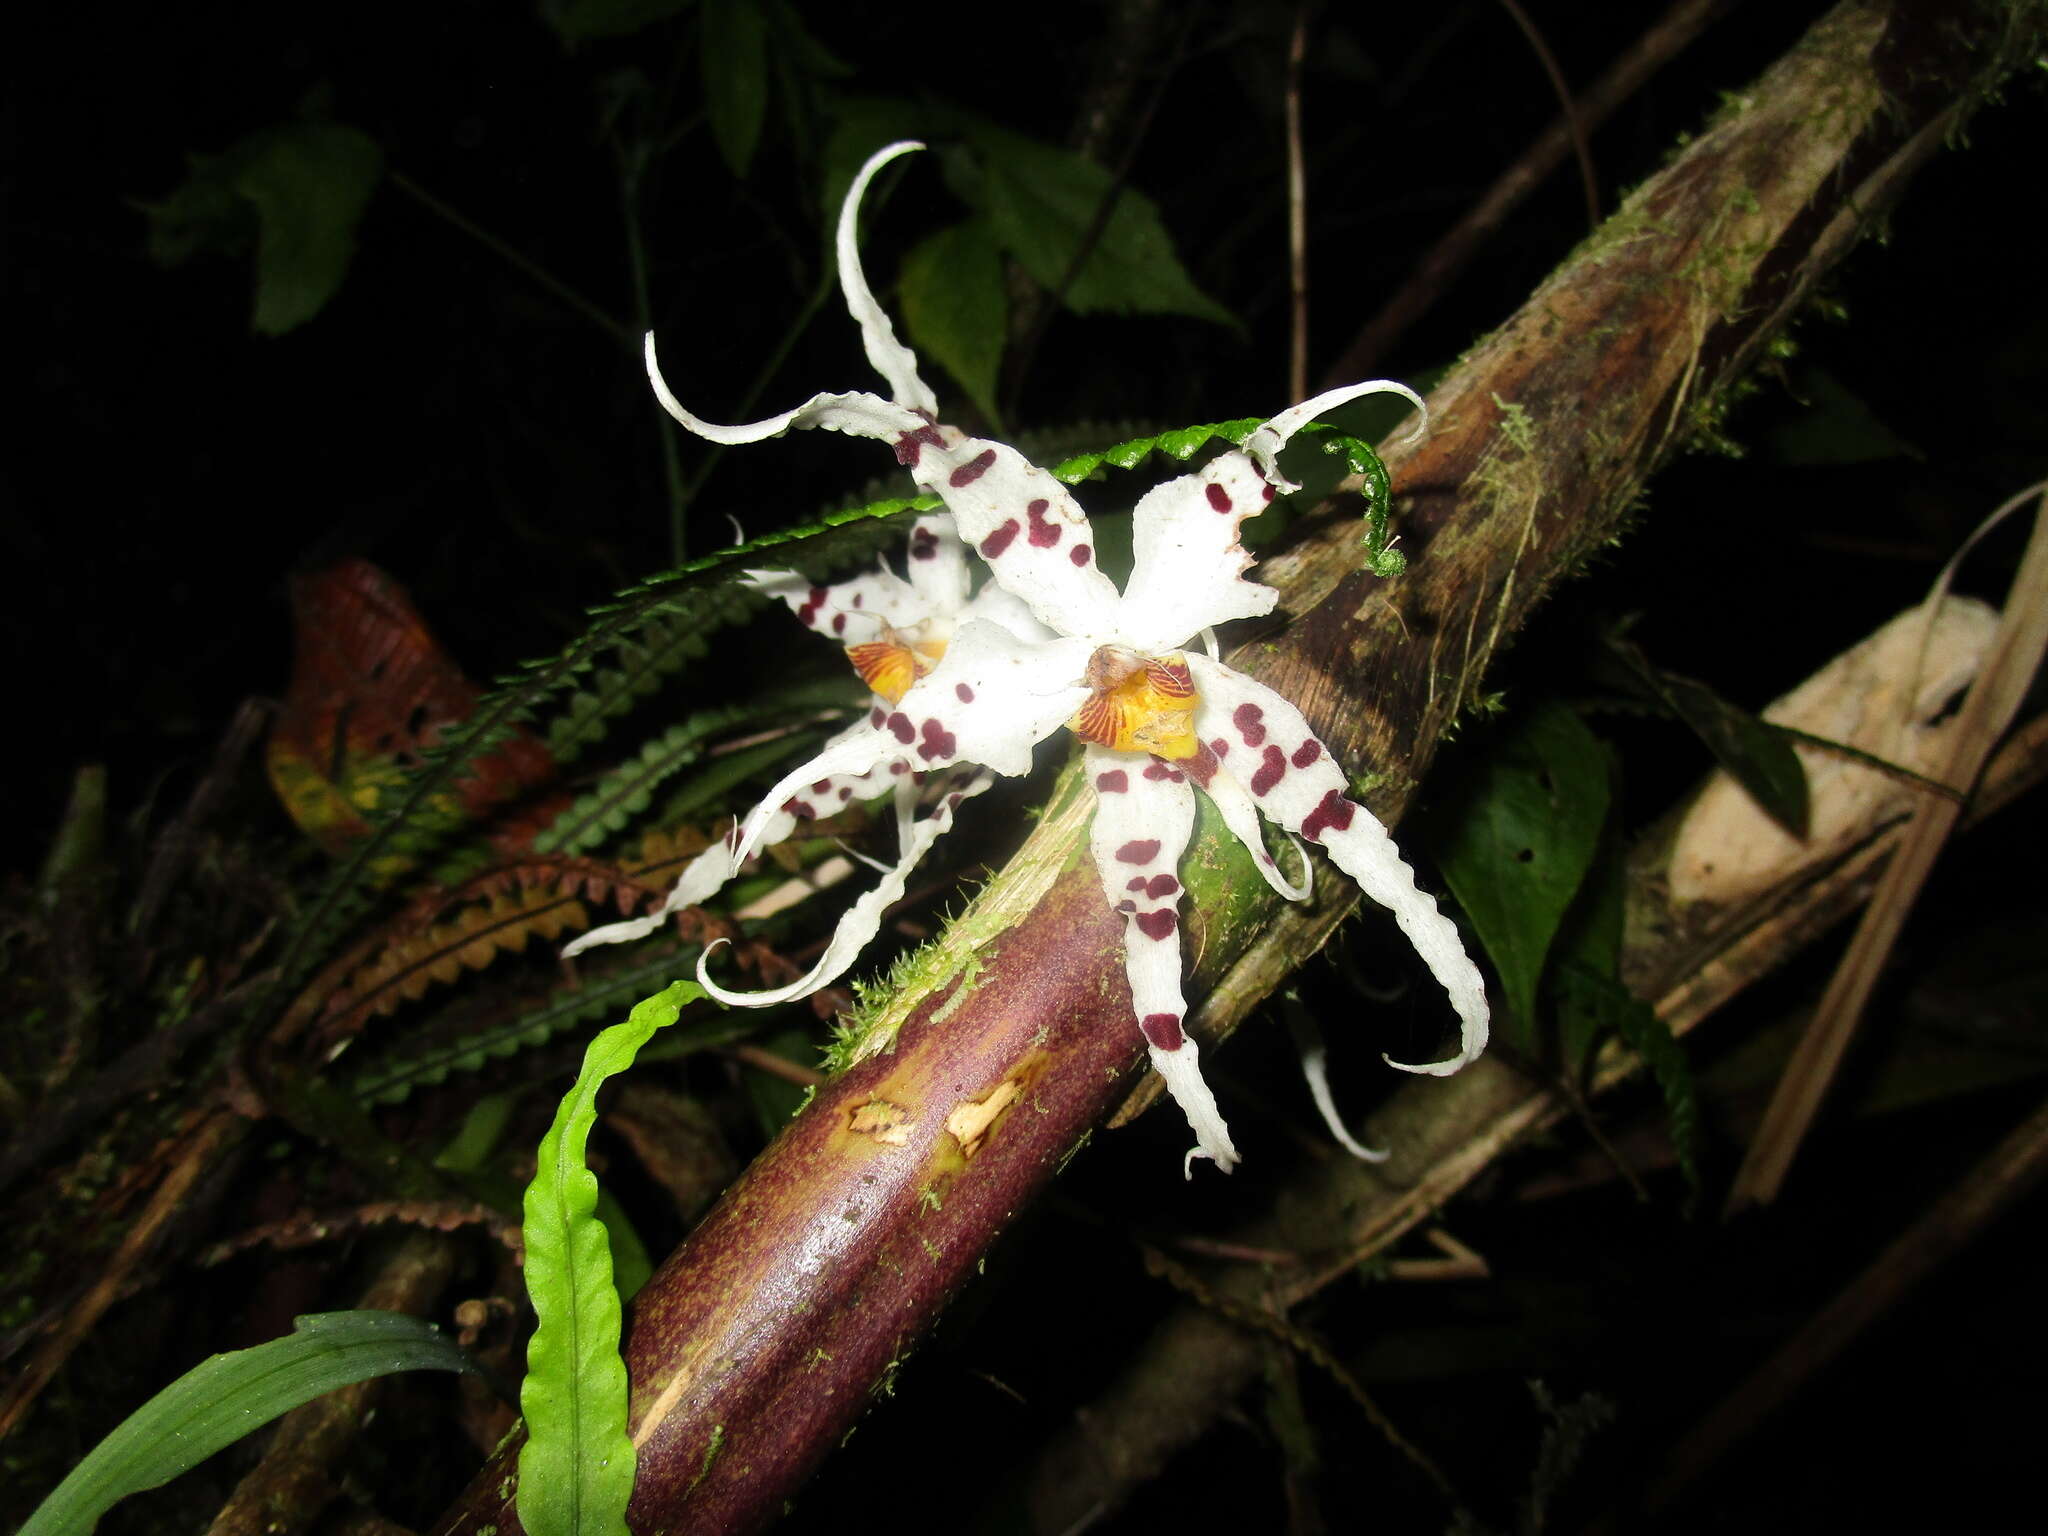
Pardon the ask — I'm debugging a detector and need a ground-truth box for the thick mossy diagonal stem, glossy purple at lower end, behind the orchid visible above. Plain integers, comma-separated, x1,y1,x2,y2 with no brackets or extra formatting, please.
438,0,2038,1536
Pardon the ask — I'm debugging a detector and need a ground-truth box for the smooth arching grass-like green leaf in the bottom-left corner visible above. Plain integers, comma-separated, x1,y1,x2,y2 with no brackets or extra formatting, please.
20,1313,475,1536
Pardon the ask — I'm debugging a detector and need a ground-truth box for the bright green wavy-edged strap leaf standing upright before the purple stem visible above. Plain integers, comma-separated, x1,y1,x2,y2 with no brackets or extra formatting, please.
518,981,705,1536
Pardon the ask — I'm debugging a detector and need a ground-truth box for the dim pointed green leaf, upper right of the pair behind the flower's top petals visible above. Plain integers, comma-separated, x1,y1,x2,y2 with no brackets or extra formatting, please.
963,117,1237,326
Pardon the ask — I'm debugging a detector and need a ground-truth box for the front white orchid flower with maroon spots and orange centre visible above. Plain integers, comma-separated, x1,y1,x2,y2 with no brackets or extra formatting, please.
630,143,1487,1169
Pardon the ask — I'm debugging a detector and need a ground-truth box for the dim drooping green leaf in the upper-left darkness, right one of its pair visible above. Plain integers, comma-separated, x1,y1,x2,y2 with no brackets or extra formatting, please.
236,123,383,336
